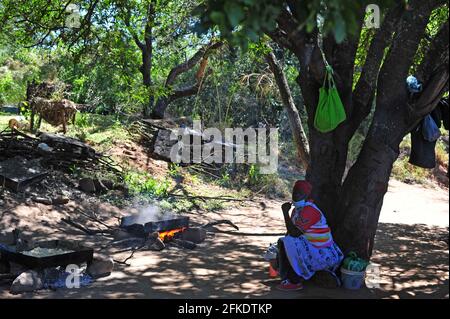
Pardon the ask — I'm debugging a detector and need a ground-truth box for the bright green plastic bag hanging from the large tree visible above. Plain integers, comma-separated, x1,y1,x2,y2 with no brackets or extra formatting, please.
314,65,347,133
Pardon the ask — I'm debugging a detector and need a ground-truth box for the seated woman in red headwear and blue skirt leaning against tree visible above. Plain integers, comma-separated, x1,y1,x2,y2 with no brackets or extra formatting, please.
277,181,344,291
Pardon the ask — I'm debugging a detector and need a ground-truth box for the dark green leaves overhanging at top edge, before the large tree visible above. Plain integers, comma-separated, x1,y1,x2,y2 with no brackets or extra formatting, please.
196,0,393,49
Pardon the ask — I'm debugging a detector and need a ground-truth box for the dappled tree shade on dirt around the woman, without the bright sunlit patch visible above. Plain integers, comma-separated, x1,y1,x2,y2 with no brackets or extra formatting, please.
0,200,449,299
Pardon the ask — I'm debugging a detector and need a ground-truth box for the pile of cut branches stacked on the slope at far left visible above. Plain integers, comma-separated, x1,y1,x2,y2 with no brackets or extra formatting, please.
0,128,121,172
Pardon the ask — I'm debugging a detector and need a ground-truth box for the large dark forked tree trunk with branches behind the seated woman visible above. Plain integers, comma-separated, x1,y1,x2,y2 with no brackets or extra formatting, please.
269,0,449,259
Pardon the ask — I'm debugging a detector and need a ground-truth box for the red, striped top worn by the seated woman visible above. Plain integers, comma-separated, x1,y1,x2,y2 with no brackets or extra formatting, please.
291,202,333,248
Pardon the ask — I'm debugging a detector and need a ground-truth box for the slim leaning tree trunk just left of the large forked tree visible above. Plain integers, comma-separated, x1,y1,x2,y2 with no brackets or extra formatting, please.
266,51,309,170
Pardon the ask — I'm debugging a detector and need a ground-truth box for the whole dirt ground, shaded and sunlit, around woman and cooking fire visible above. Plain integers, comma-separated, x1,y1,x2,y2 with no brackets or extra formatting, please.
0,181,449,299
